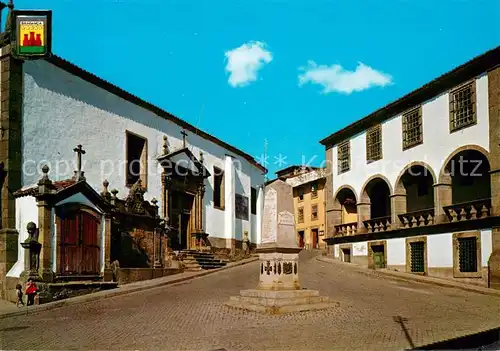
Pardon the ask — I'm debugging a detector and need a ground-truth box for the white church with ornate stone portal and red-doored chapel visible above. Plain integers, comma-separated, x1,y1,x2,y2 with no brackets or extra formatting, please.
0,10,267,302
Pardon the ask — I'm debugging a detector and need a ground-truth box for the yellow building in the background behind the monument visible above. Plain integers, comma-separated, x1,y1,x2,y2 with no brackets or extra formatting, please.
276,166,326,249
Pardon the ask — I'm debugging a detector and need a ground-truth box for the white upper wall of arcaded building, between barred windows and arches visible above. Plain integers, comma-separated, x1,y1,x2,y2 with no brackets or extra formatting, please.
330,74,489,199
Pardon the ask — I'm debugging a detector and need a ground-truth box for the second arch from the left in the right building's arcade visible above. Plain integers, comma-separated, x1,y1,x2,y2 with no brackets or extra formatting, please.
360,174,393,220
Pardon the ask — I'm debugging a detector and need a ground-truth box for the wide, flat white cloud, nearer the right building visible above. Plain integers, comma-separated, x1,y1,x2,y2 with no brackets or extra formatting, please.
299,61,392,94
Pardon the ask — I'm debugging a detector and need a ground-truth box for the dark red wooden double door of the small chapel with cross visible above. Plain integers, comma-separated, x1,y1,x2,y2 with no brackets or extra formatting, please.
59,211,100,275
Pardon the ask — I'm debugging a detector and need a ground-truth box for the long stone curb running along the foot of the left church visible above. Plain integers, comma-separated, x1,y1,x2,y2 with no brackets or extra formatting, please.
0,257,258,319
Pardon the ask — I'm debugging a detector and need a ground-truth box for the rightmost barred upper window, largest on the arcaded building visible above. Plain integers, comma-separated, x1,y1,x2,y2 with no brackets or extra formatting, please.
450,82,476,132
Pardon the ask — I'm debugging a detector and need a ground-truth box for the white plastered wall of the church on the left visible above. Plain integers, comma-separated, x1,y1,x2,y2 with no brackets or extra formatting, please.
22,60,264,243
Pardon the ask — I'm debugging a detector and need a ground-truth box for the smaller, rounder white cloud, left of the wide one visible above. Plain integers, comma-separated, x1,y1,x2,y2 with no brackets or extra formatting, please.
225,41,273,87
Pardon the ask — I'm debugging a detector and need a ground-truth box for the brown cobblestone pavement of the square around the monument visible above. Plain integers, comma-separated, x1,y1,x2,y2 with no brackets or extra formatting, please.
0,259,500,351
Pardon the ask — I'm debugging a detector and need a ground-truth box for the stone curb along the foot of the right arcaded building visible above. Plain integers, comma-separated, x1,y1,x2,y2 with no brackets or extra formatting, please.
316,257,500,297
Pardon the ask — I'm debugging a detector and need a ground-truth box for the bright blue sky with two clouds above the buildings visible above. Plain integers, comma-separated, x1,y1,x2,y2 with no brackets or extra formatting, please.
14,0,500,177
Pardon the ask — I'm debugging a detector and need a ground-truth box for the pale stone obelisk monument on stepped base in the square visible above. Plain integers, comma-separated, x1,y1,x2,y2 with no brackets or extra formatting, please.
226,179,337,314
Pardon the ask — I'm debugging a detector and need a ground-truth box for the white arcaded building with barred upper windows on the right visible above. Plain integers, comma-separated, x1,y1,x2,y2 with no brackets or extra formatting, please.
321,47,500,288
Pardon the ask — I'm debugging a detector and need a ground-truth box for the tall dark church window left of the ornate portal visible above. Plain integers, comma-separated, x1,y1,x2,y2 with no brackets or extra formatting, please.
125,131,148,188
